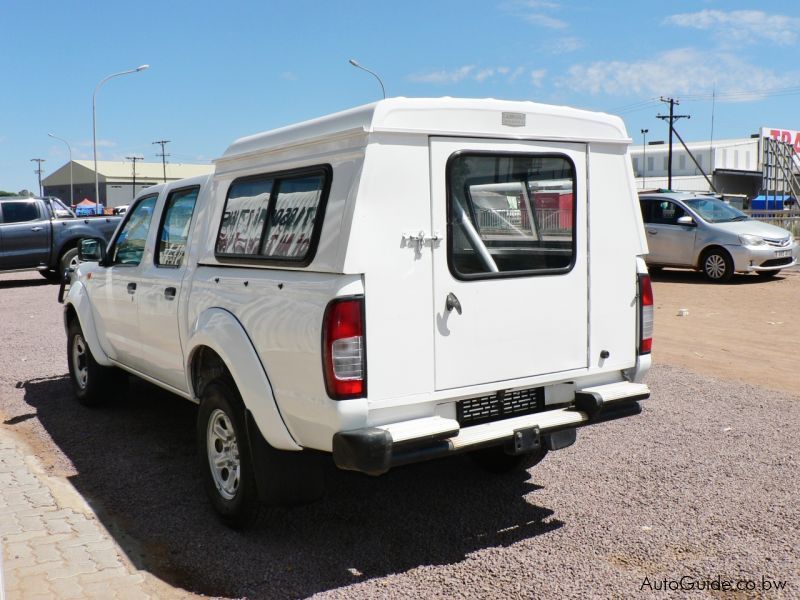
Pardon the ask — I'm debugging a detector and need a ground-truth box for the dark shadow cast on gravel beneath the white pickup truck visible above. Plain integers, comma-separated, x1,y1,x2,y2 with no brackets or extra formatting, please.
19,376,563,598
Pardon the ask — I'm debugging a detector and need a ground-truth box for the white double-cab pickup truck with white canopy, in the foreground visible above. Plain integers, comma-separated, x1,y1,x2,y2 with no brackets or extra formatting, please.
64,98,653,526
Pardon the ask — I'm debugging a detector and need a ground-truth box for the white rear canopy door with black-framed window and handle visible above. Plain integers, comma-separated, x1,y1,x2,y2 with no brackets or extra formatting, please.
430,138,588,390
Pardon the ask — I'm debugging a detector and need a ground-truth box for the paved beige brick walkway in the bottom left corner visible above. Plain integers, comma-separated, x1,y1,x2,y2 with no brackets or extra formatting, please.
0,425,156,600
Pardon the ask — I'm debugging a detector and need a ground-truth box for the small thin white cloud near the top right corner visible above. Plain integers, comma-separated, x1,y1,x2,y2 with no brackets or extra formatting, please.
664,10,800,46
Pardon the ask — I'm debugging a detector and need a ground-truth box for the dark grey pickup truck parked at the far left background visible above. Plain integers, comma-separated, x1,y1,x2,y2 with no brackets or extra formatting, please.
0,197,121,281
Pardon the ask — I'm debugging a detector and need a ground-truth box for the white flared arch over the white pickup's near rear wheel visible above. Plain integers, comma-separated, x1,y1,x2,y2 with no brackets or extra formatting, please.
186,308,302,451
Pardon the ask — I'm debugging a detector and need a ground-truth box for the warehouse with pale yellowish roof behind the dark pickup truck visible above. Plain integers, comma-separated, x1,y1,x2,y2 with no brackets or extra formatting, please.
42,160,214,208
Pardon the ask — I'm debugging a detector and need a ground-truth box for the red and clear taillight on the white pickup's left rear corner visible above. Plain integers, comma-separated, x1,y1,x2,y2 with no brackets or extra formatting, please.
322,298,367,400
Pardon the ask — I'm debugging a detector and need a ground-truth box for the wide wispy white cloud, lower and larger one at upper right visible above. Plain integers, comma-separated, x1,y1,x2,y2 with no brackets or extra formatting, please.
556,48,797,101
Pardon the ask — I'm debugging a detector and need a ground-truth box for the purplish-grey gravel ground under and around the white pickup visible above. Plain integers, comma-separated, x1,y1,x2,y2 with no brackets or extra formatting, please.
0,274,800,598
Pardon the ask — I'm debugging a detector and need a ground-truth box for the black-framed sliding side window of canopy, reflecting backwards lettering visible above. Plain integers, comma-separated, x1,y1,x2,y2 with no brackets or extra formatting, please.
214,165,331,266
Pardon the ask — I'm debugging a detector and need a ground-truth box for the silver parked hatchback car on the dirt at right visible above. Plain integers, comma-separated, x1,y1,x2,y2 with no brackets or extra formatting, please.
639,192,800,282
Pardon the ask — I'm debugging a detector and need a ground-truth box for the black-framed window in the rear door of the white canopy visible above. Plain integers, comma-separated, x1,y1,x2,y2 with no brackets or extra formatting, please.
447,152,576,279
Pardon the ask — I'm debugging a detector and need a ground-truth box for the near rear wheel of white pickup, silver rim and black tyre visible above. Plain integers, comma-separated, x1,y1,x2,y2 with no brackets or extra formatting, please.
197,379,261,529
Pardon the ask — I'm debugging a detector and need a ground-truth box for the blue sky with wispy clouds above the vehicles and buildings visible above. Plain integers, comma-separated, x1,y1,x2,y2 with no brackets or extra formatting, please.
0,0,800,192
